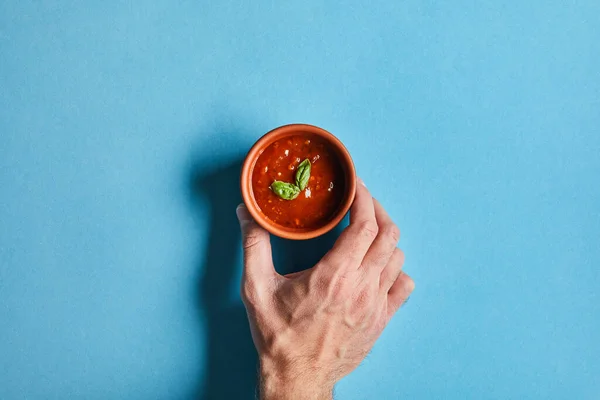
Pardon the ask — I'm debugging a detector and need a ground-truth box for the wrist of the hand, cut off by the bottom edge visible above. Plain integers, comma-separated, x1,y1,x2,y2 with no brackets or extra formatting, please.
260,357,335,400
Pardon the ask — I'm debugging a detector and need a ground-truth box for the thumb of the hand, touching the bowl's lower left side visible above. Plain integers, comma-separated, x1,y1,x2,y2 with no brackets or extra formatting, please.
235,204,275,286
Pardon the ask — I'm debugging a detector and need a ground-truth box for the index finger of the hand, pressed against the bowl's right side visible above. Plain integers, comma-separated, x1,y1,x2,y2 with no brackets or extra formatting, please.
323,178,378,268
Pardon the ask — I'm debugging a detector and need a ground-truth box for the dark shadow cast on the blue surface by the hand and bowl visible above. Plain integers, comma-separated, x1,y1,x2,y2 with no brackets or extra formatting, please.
191,149,341,400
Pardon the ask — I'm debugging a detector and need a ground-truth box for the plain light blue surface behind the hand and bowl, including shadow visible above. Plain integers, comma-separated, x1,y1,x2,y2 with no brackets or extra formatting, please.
0,0,600,399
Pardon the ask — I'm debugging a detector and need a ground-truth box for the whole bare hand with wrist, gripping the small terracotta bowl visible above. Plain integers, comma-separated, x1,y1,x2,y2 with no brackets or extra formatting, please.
236,180,414,400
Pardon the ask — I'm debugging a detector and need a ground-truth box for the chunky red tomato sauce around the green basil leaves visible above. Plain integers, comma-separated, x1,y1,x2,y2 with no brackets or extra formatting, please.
252,134,345,229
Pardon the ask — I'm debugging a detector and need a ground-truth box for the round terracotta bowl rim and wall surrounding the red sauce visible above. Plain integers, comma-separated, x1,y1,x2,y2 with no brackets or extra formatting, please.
240,124,356,240
